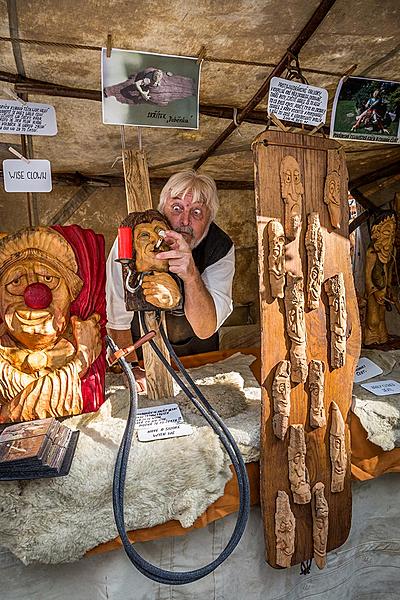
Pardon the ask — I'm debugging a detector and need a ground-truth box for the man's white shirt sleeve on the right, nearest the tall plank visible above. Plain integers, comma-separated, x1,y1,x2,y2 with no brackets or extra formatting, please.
201,245,235,329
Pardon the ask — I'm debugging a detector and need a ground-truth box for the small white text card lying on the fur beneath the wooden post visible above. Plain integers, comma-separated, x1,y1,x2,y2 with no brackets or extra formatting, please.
135,404,193,442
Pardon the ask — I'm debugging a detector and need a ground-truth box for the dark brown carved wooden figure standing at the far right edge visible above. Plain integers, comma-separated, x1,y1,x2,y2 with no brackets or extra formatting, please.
364,211,396,345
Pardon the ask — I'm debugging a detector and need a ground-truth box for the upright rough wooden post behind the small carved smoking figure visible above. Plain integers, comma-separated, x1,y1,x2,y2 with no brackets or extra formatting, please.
122,150,174,400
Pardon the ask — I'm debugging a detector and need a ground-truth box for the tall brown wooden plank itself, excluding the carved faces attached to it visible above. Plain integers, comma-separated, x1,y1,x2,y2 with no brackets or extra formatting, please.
253,132,361,567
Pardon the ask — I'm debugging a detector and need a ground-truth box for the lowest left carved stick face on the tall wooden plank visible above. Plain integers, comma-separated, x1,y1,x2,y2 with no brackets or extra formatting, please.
275,490,296,567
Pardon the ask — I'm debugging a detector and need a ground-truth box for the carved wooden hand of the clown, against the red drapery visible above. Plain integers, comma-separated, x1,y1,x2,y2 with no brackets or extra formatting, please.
71,313,102,376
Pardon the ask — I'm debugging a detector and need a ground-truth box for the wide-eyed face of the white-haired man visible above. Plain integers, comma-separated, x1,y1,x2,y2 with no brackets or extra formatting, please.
164,192,211,249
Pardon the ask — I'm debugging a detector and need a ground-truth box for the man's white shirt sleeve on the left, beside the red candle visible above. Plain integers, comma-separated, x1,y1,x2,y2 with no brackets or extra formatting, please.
106,238,134,331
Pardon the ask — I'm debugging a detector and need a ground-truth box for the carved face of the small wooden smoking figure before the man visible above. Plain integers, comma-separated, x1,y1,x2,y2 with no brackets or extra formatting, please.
133,220,168,273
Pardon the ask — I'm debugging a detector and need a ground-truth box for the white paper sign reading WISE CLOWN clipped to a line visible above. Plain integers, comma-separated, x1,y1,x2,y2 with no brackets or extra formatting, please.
3,159,52,192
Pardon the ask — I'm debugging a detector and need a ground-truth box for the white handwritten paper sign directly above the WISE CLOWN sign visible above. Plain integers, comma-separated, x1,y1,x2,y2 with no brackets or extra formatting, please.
0,100,57,135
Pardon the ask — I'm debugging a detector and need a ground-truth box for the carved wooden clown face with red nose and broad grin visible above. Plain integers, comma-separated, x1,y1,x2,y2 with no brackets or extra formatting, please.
0,258,71,350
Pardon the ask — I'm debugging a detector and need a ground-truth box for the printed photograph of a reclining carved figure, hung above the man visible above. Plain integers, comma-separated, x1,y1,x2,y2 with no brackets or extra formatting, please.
101,48,200,129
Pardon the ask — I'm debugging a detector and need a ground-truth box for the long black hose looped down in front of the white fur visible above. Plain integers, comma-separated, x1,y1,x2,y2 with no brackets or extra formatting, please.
106,313,250,585
